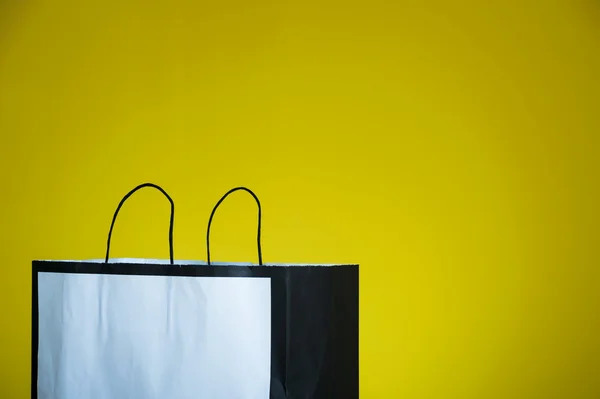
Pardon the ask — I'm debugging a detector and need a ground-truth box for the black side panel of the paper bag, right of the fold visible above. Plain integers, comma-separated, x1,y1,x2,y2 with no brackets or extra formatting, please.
286,266,358,399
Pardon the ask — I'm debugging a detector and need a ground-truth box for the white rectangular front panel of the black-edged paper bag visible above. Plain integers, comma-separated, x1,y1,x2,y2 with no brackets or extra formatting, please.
38,273,271,399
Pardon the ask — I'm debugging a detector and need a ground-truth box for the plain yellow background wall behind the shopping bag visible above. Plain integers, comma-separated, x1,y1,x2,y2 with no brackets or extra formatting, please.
0,0,600,399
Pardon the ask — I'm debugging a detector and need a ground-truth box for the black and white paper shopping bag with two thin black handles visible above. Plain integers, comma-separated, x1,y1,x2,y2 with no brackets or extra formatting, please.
32,184,358,399
